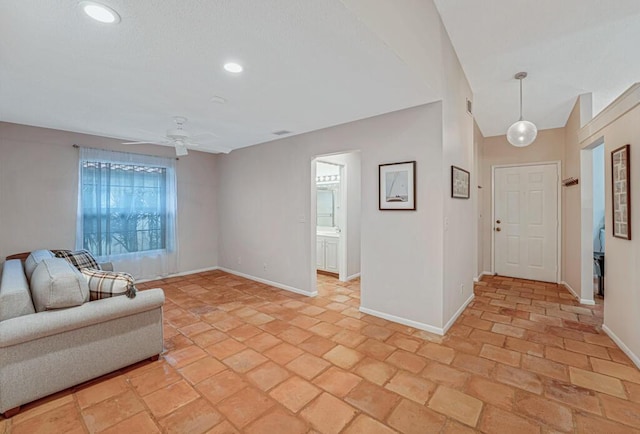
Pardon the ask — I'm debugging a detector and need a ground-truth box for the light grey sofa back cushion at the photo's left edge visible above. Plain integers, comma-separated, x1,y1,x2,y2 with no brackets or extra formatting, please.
0,259,36,321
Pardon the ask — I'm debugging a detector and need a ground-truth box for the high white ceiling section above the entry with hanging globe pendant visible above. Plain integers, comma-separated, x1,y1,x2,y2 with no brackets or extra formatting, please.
435,0,640,137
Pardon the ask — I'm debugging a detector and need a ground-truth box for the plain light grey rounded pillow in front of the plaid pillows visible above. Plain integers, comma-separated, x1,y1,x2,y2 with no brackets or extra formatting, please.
31,258,89,312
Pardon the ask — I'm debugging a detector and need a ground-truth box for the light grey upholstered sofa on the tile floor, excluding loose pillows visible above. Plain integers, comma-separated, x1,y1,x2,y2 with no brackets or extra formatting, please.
0,253,164,417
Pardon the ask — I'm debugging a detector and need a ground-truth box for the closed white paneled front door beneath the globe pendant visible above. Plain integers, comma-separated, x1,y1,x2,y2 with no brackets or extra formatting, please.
493,164,560,282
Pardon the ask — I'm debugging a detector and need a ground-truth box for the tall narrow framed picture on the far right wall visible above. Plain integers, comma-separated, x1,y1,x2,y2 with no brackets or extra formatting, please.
611,145,631,240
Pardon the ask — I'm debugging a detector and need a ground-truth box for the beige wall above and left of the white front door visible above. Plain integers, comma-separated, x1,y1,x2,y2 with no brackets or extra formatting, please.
480,128,565,272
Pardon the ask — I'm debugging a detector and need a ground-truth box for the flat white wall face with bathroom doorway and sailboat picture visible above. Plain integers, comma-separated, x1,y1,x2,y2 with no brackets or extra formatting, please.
218,103,444,324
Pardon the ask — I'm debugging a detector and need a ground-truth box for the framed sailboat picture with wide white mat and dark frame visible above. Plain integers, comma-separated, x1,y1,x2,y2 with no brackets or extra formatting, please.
378,161,416,211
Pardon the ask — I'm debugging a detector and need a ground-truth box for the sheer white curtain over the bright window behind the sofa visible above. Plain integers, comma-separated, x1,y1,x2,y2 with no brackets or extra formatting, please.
76,147,178,279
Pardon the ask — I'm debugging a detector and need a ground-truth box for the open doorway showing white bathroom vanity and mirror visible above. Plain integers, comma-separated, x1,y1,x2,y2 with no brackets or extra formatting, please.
311,151,361,287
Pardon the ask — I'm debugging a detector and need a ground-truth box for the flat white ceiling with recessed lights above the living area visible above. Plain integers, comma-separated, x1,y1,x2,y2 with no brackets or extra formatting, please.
0,0,437,152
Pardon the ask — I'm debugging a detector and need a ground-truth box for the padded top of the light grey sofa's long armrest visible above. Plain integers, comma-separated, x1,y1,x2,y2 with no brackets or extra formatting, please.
0,288,164,348
